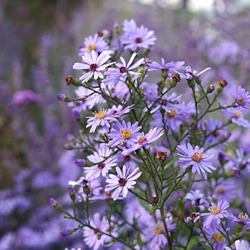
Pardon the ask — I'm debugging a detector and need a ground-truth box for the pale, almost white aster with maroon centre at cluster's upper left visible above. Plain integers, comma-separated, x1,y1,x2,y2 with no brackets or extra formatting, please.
73,50,113,82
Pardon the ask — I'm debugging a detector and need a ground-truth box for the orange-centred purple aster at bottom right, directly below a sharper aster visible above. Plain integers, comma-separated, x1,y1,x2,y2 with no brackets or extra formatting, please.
204,224,227,250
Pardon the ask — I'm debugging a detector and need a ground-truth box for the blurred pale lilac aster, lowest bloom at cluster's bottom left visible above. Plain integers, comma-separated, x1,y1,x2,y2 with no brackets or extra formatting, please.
83,213,112,250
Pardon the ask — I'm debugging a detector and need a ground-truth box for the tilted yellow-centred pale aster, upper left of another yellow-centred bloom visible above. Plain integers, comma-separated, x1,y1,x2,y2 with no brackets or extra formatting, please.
86,109,117,133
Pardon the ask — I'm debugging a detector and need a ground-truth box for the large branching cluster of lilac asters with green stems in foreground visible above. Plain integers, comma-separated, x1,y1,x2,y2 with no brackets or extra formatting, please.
52,20,250,250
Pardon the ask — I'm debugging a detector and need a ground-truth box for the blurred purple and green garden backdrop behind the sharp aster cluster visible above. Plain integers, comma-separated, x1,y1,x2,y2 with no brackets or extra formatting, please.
0,0,250,250
